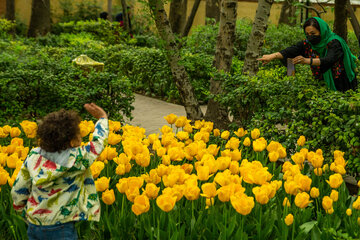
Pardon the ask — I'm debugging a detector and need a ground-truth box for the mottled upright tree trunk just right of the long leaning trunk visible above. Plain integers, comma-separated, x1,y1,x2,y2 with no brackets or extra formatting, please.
205,0,237,129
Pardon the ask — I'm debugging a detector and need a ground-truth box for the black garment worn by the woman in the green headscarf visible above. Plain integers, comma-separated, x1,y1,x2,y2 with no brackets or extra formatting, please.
280,39,357,92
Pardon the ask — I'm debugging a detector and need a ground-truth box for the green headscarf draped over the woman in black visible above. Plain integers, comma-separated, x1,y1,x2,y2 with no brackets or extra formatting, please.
304,17,356,91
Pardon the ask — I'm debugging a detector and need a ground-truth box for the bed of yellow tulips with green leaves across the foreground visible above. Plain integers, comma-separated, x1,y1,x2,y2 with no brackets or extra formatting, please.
0,114,360,239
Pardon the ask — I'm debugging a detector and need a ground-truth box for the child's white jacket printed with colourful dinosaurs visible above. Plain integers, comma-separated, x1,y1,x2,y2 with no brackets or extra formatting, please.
11,118,109,225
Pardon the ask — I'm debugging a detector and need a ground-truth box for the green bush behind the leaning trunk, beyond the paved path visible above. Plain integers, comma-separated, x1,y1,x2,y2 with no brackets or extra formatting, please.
105,46,212,102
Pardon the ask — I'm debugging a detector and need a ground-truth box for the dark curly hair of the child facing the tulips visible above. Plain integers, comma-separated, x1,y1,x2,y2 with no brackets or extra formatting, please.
37,109,81,152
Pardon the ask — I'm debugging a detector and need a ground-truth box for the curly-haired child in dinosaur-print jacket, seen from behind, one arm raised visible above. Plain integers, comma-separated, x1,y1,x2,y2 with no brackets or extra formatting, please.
11,103,109,240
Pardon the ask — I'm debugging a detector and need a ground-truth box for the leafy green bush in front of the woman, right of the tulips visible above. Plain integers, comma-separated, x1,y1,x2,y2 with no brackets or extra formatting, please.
220,61,360,173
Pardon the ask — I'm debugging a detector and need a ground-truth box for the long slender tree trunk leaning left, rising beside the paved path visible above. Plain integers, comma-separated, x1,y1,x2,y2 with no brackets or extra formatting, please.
149,0,203,120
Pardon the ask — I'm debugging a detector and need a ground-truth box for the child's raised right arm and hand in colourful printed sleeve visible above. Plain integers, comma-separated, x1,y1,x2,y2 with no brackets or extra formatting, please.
76,103,109,168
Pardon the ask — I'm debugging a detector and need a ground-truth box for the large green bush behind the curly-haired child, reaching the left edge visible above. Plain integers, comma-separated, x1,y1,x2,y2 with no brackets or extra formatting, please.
0,38,134,122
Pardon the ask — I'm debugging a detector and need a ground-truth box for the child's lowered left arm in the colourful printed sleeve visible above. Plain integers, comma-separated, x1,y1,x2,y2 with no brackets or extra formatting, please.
11,158,31,212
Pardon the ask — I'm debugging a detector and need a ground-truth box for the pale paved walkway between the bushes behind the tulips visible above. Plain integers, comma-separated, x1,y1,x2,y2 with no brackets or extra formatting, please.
125,94,206,135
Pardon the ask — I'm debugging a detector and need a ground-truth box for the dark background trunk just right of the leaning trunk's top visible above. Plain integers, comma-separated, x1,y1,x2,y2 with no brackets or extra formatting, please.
169,0,187,34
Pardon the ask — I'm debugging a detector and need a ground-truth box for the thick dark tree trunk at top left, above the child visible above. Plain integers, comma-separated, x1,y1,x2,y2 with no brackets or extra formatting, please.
27,0,51,37
